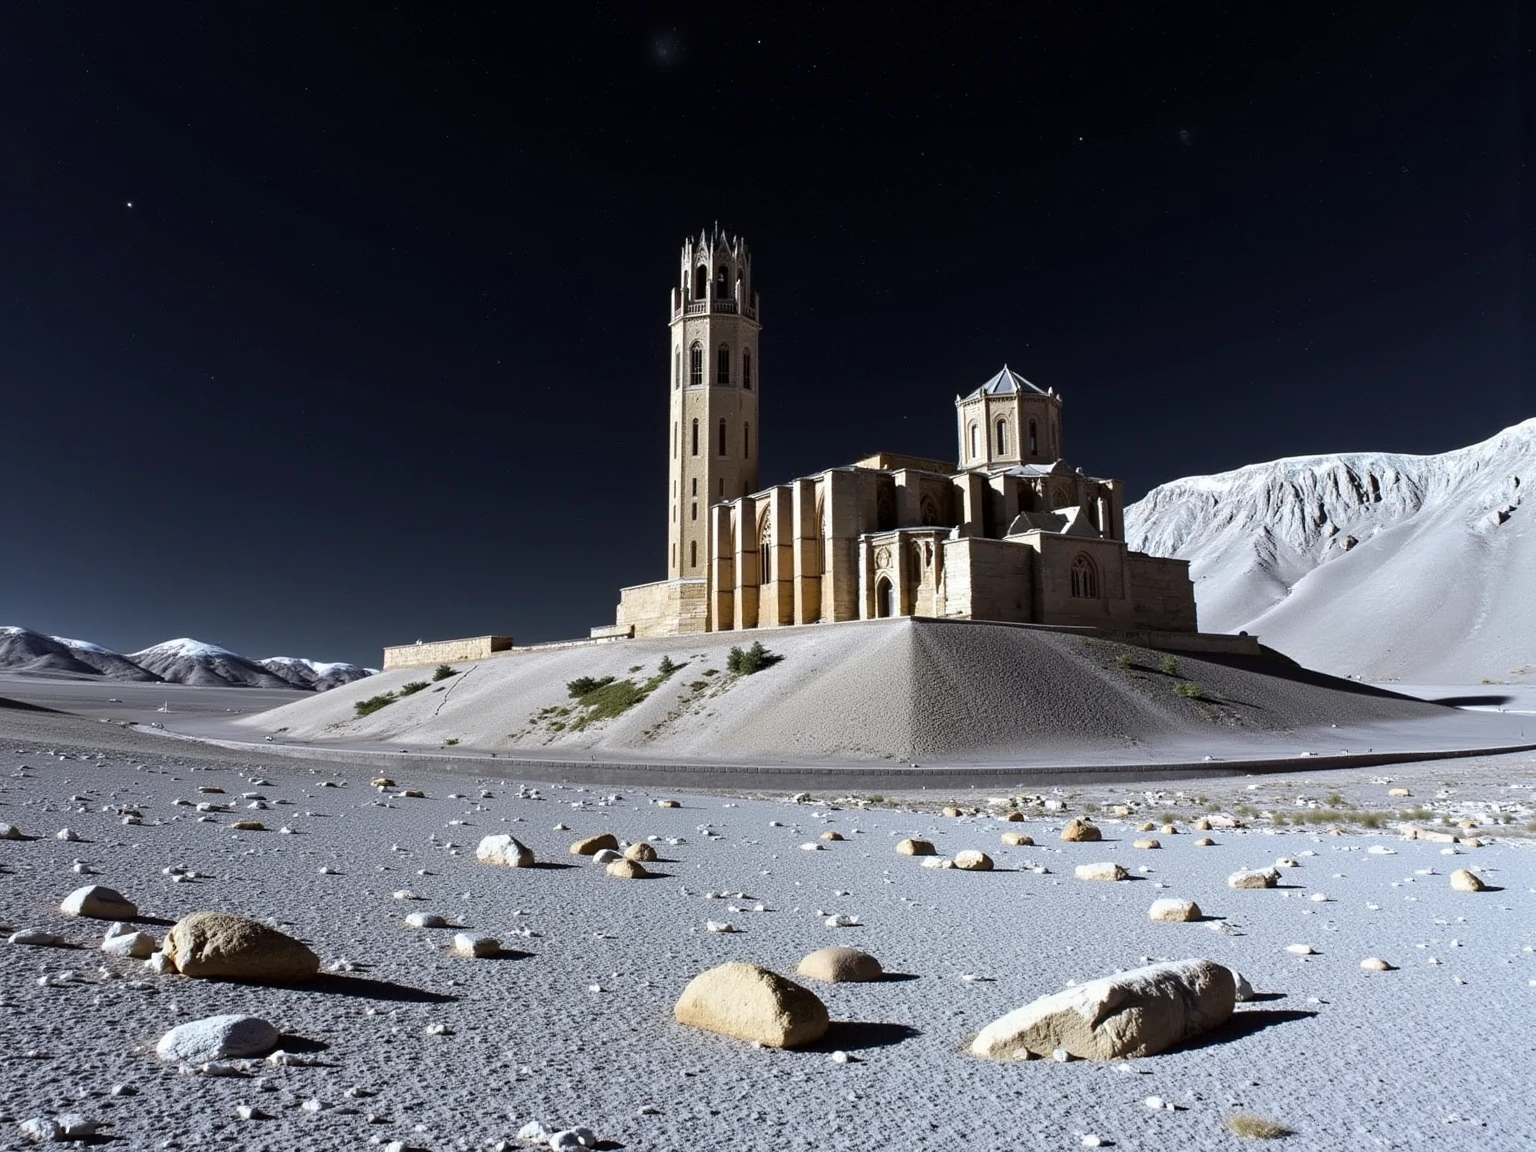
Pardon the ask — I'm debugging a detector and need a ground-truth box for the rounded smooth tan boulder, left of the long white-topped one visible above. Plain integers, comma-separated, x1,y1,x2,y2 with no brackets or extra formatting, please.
673,963,828,1048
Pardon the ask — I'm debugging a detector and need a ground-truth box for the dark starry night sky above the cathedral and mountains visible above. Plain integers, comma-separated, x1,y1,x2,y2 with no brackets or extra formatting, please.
0,0,1536,664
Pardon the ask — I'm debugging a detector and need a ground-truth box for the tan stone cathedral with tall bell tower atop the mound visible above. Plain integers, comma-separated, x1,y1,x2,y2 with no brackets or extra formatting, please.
593,230,1197,636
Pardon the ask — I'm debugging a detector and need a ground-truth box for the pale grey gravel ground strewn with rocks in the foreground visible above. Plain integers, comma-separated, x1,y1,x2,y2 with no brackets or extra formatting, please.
0,710,1536,1152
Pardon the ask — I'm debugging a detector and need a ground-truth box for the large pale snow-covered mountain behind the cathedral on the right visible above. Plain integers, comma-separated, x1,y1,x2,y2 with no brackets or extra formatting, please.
1126,419,1536,682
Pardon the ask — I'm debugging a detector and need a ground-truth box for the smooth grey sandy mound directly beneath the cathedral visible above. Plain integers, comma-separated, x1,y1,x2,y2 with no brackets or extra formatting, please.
224,619,1474,763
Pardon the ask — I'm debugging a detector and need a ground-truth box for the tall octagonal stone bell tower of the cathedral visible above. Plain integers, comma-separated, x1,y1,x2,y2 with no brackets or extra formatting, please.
667,224,762,581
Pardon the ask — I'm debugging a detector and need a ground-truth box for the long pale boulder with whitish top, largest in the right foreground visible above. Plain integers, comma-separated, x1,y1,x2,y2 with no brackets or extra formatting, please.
971,960,1236,1060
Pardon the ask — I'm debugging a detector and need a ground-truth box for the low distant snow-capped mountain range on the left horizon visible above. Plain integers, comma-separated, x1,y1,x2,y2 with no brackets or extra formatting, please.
0,627,375,691
